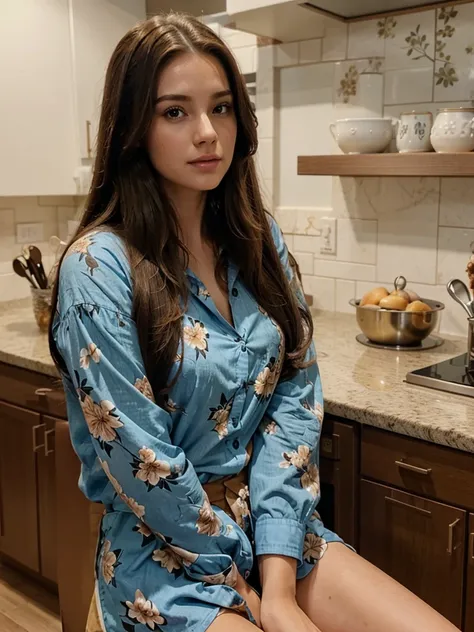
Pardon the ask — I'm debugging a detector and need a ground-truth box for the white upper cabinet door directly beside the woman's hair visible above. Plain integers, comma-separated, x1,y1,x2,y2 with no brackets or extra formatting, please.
72,0,146,158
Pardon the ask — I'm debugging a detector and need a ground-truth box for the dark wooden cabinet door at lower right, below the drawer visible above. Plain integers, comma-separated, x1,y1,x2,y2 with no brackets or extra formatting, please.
360,480,466,628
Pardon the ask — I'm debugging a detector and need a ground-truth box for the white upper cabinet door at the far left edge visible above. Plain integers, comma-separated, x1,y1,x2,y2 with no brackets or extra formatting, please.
0,0,78,196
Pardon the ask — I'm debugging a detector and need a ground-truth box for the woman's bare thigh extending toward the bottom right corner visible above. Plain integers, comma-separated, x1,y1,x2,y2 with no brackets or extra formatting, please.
297,543,457,632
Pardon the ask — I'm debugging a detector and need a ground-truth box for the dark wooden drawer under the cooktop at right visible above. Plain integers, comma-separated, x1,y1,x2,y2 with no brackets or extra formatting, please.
361,426,474,510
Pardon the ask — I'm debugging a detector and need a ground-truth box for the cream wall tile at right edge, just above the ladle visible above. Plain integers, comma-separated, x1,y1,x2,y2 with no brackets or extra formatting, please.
436,227,474,284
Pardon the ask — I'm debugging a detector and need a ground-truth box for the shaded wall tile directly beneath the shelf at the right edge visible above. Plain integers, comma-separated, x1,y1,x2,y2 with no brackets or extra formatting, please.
439,178,474,228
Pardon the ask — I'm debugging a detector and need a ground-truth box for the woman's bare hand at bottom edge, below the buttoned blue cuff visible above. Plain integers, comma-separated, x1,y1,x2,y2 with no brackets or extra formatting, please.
260,596,320,632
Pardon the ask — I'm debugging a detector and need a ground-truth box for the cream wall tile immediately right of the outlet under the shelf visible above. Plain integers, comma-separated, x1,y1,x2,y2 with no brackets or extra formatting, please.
337,219,377,264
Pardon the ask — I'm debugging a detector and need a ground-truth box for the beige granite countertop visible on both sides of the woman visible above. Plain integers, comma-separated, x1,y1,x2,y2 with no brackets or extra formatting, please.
0,299,474,453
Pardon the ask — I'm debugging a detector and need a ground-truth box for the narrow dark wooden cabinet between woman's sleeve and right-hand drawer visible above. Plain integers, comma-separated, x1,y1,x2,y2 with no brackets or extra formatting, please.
318,416,359,548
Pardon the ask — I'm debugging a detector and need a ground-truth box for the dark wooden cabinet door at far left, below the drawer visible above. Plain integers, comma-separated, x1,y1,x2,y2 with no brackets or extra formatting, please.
0,402,43,571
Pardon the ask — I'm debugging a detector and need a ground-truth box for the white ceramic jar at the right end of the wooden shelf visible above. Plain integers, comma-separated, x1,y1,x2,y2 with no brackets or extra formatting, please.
431,108,474,153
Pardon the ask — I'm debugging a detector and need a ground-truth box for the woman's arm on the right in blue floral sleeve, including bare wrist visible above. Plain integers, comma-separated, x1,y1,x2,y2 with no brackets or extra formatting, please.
250,217,323,602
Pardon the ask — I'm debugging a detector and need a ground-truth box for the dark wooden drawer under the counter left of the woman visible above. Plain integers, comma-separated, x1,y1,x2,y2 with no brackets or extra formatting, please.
0,362,67,418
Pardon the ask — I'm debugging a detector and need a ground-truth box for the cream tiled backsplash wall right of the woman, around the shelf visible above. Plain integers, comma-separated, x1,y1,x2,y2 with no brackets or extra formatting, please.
257,3,474,334
